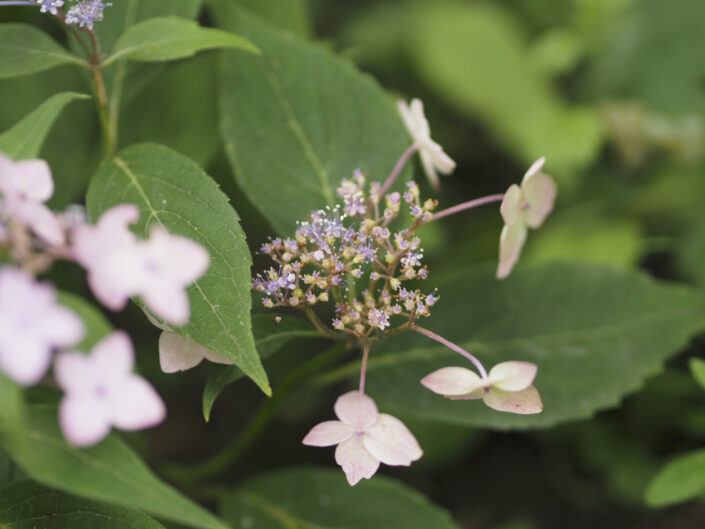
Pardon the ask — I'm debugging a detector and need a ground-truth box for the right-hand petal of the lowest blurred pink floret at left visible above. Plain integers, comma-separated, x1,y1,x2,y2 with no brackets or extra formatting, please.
109,375,166,431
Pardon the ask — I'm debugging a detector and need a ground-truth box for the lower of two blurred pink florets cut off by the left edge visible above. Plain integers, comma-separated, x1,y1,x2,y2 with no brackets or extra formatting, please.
0,267,84,386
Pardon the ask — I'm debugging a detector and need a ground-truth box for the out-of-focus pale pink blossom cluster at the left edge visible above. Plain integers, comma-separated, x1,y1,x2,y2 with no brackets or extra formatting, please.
0,154,209,446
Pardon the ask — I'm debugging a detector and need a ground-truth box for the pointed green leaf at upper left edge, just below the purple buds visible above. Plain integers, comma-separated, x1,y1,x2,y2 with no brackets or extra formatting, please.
0,23,86,79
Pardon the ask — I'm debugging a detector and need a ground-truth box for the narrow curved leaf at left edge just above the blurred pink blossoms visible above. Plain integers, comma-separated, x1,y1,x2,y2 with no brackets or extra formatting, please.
0,92,90,160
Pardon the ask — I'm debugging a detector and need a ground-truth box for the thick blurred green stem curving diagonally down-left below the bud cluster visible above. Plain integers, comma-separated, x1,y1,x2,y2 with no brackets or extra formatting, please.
162,343,347,483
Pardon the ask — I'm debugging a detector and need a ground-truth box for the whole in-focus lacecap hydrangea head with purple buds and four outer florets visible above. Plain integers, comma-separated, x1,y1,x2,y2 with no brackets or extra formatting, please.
252,100,556,485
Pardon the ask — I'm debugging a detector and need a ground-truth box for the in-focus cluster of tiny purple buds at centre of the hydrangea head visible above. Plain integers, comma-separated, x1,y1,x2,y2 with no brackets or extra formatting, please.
252,171,438,338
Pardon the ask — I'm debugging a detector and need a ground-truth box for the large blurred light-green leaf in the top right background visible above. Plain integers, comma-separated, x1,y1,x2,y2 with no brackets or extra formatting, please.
408,2,602,175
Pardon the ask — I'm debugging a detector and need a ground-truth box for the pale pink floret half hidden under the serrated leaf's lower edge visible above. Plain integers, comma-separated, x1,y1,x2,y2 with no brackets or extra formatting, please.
147,314,233,374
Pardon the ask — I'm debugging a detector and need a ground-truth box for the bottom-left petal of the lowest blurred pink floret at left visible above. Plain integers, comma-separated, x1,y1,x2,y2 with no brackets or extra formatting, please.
59,395,110,446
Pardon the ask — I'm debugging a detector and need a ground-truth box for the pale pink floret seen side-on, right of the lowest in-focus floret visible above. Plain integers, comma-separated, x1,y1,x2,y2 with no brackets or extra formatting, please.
421,361,543,415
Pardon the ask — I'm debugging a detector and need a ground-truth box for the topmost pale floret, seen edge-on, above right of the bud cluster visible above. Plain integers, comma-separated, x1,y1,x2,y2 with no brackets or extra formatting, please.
397,99,455,189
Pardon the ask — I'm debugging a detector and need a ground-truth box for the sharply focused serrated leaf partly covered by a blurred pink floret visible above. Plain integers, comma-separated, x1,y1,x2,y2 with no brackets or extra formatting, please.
86,144,271,394
